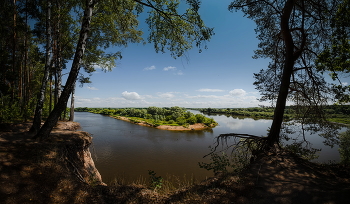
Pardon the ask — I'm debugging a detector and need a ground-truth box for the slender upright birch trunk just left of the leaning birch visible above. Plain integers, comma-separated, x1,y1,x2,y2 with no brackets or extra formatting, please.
30,1,51,133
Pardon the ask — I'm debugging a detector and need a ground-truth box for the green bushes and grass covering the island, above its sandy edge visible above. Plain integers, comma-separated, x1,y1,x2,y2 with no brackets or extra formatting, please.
75,106,217,127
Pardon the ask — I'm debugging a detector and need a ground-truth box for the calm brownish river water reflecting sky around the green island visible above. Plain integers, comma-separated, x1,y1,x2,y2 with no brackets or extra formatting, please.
75,111,339,183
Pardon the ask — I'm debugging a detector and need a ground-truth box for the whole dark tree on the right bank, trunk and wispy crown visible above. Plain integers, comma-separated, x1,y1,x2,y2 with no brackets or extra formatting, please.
229,0,339,148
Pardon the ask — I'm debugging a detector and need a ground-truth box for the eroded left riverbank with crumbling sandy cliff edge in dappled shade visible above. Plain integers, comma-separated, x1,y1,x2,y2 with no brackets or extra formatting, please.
0,122,105,203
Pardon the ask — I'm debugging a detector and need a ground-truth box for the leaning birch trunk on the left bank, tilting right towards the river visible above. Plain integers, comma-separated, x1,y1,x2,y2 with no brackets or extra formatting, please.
34,0,96,139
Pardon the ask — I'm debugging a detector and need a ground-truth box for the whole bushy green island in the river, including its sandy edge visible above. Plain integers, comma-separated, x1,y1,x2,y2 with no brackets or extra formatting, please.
74,106,218,131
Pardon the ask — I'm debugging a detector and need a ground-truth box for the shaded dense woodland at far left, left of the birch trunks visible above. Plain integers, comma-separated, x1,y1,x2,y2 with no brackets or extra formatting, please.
0,0,44,122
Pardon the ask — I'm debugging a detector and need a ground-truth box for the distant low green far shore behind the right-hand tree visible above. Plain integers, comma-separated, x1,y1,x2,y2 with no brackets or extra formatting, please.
191,105,350,124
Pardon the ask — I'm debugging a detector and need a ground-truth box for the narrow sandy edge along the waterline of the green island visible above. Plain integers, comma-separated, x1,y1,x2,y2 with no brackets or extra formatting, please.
111,116,211,131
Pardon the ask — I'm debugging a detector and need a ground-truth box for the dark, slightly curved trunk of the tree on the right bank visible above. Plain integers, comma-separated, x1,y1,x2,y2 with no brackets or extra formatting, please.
267,0,295,148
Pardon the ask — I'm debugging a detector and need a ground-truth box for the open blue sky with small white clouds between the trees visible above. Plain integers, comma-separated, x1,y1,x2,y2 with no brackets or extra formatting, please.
75,0,269,108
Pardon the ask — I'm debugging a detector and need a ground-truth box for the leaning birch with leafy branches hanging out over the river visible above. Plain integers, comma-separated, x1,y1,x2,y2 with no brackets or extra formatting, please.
34,0,213,139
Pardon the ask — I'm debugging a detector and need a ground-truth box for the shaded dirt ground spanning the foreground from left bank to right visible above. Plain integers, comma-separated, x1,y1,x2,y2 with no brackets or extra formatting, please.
0,123,350,204
